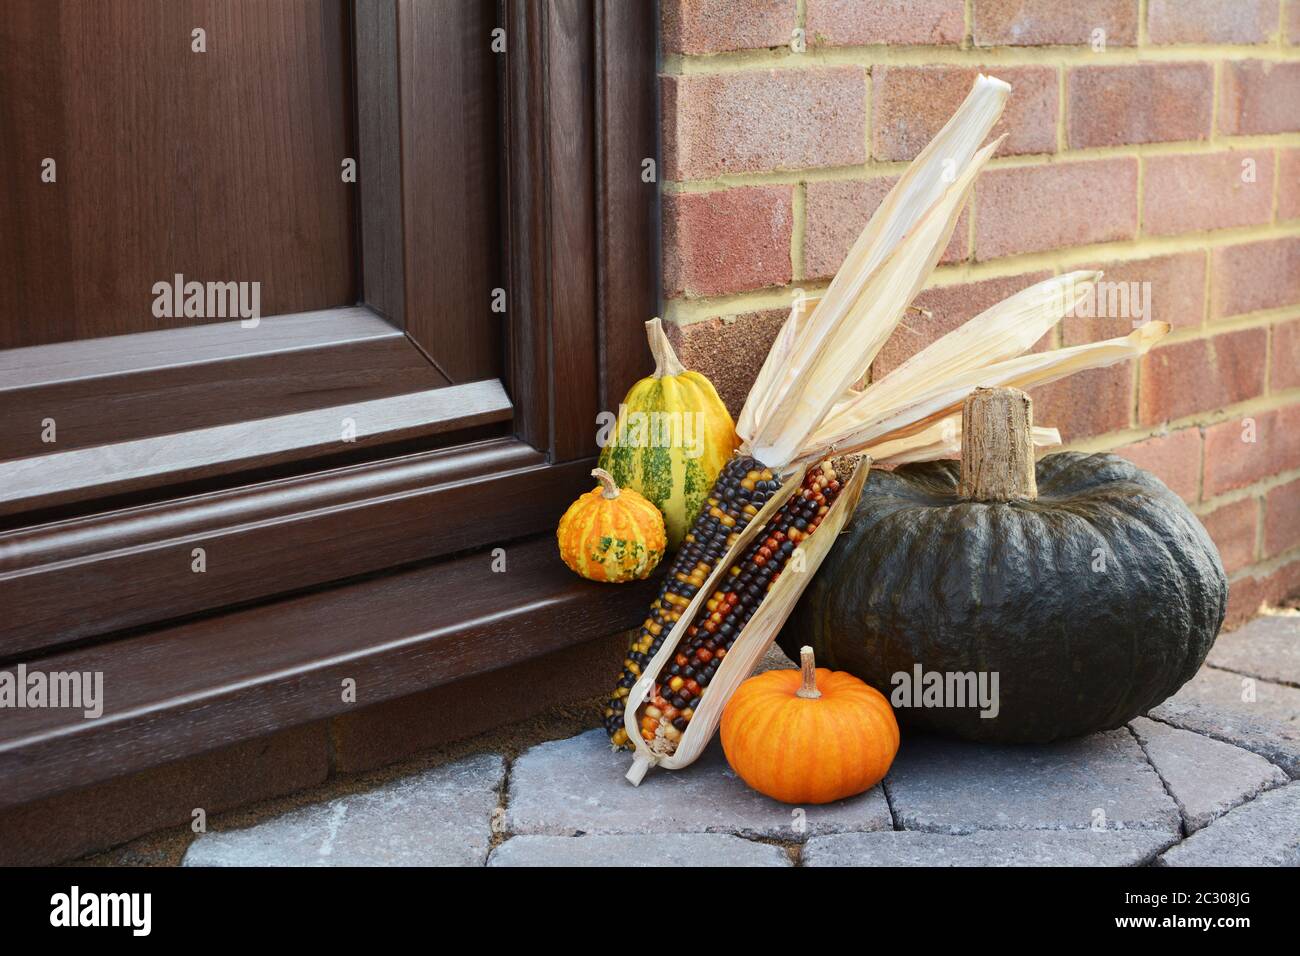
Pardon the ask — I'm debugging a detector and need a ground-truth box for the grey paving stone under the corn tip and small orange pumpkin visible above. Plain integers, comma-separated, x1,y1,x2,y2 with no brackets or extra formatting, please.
506,730,889,840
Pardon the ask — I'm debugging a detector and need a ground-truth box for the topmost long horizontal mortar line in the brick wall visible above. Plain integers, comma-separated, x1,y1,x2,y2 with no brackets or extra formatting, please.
660,43,1300,77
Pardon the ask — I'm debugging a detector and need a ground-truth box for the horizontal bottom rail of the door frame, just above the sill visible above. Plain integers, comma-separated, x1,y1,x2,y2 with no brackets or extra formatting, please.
0,437,595,658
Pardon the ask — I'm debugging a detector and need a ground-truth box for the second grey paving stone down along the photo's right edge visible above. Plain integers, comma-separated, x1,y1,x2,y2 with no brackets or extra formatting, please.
1149,667,1300,779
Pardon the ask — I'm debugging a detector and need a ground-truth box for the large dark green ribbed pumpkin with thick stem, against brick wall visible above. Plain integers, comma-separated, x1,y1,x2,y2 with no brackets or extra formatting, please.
779,389,1227,743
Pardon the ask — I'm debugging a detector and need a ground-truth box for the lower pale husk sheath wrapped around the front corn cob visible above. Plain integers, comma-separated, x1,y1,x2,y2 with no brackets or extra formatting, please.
623,457,871,784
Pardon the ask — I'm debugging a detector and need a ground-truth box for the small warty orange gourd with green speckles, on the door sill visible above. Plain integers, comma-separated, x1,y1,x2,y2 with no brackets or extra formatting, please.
555,468,668,584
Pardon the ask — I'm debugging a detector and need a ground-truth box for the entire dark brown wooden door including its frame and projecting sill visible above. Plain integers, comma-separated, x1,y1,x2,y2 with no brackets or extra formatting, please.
0,0,658,808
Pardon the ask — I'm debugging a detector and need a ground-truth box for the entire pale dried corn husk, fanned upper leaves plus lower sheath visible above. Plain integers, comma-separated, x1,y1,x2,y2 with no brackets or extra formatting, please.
624,75,1169,783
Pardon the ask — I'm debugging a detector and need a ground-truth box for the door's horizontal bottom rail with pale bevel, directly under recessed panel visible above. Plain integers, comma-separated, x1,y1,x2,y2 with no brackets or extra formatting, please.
0,306,447,457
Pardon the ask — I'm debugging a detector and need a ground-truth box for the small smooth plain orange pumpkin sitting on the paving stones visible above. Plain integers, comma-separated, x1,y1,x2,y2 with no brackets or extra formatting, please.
722,648,898,804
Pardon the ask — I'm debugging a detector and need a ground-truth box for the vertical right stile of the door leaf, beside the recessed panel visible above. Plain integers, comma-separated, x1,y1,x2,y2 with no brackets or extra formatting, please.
356,0,511,384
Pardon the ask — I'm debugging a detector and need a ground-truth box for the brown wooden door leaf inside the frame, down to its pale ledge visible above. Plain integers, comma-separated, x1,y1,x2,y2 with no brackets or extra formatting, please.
0,0,511,494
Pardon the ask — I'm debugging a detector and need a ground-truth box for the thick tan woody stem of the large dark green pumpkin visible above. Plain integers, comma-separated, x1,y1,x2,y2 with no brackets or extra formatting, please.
957,388,1039,501
